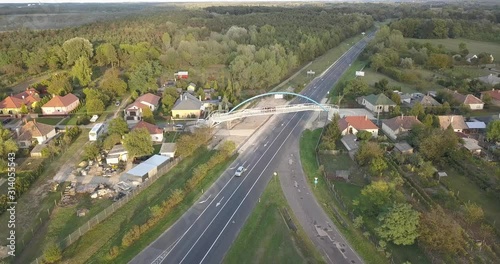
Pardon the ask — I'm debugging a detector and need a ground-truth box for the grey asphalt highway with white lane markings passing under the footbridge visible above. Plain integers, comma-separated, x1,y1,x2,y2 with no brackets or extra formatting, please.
130,32,374,264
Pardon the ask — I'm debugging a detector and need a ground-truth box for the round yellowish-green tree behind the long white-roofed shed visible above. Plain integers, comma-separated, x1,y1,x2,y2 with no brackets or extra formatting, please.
123,128,154,158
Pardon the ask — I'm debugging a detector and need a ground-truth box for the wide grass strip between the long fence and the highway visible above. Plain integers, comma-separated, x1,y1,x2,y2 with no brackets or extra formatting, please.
63,149,235,263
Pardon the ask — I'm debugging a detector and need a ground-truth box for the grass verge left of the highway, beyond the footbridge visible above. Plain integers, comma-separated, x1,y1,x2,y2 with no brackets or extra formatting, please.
282,35,363,92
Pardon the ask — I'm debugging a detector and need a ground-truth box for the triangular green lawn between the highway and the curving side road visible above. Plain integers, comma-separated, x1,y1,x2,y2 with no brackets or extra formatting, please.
223,170,324,264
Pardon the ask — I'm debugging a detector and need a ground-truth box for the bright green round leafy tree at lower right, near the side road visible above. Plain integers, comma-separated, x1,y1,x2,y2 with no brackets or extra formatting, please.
375,203,420,245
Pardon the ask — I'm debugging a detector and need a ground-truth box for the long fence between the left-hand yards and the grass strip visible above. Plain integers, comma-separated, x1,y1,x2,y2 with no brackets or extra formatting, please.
32,158,182,264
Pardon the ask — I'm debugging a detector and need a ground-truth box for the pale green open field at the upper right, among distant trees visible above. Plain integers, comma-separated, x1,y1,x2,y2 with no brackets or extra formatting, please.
407,38,500,61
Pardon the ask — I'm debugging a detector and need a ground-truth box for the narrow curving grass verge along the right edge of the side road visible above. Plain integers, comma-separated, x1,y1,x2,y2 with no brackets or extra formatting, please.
300,129,388,263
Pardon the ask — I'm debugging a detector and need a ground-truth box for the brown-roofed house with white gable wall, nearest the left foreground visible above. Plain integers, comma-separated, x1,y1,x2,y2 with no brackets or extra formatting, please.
16,120,56,148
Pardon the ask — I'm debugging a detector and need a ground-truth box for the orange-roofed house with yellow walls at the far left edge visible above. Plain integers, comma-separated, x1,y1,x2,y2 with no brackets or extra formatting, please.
0,88,40,115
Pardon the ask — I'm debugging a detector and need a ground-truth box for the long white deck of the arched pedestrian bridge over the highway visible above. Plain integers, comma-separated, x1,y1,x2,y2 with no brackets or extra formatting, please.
207,103,339,126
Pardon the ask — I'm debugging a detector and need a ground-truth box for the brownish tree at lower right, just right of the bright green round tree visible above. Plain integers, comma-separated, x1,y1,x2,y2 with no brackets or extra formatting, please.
419,208,465,254
